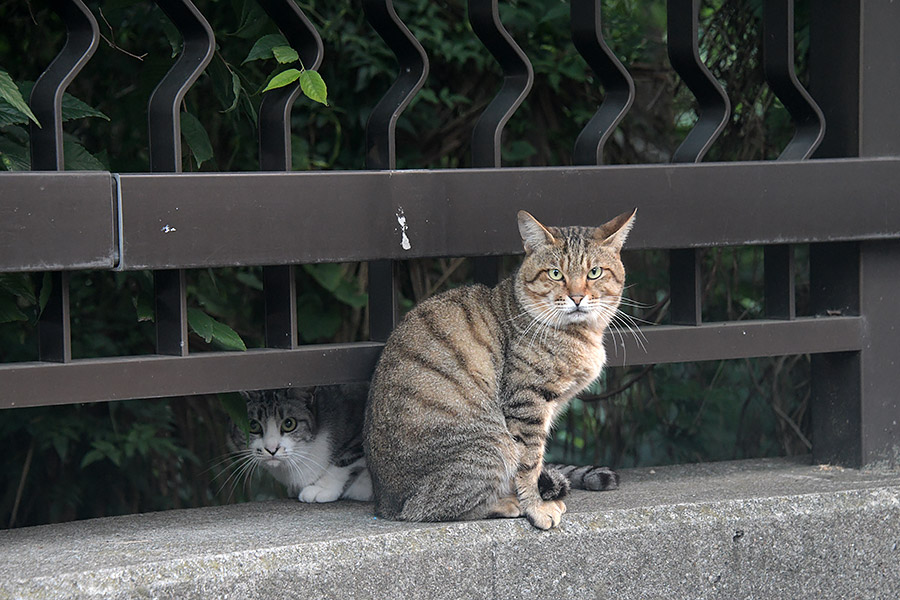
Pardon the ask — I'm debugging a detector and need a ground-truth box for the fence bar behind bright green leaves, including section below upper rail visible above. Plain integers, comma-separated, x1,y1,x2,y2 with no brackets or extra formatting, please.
258,0,323,348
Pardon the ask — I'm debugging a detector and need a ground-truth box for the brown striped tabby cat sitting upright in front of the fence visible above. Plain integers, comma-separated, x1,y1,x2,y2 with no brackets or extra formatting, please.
363,211,637,529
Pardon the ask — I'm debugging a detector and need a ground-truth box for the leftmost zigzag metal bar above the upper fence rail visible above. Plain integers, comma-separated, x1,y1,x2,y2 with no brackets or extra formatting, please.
31,0,100,171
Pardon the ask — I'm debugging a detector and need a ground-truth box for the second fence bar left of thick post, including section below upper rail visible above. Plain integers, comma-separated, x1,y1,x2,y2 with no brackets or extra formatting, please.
667,0,731,325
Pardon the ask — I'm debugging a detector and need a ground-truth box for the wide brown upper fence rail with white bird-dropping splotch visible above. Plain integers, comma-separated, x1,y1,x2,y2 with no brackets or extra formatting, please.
0,158,900,271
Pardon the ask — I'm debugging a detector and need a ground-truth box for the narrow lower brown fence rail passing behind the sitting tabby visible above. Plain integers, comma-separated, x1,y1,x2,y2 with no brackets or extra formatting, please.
0,317,864,408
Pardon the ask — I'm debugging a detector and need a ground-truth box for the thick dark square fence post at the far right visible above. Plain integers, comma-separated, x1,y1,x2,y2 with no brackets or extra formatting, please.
810,0,900,467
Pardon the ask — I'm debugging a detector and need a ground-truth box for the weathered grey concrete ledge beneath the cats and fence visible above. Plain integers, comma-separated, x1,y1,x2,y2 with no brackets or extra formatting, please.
0,460,900,600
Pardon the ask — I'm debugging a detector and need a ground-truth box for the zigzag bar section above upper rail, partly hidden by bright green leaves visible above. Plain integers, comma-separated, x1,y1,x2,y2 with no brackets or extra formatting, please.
257,0,322,171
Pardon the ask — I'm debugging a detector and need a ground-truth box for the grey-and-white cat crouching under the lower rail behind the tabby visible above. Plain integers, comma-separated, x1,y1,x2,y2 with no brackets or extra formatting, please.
230,385,372,502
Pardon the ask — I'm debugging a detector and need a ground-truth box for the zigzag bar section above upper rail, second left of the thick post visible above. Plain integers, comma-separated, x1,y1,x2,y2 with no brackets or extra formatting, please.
668,0,731,162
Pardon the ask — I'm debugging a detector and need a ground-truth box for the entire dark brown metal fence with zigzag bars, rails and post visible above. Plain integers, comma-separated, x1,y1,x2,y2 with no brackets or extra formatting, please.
0,0,900,465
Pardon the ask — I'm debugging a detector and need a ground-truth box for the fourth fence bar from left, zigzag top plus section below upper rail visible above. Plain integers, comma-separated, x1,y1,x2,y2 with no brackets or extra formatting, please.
363,0,428,341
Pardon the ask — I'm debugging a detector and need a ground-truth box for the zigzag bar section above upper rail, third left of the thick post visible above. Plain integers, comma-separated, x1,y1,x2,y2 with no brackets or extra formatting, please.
570,0,634,165
